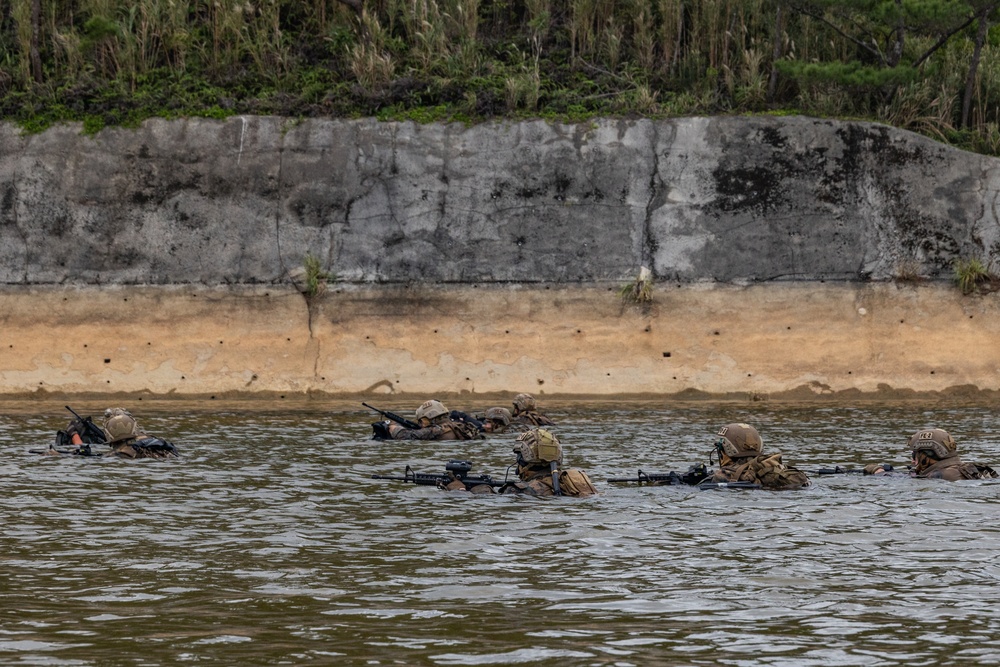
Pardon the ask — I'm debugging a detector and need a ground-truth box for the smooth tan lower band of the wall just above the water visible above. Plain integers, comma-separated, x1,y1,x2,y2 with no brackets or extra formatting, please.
0,283,1000,398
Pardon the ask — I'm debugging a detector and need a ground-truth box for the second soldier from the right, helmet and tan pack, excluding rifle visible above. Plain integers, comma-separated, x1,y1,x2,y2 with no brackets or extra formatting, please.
705,424,809,491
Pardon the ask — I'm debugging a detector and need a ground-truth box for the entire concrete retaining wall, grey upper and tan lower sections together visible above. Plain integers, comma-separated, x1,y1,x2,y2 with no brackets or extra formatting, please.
0,117,1000,397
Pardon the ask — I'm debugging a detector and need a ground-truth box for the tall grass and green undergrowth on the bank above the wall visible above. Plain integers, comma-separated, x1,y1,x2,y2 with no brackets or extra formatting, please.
0,0,1000,154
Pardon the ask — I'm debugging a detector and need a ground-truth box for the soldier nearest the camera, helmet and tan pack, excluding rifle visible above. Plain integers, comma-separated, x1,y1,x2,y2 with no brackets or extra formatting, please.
500,429,597,498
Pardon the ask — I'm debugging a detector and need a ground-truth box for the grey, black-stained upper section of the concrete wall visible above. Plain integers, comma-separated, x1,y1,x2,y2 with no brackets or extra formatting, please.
0,117,1000,285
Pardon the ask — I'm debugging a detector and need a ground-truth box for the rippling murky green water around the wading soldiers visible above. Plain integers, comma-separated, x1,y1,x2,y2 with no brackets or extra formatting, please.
0,402,1000,666
